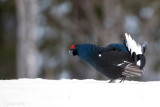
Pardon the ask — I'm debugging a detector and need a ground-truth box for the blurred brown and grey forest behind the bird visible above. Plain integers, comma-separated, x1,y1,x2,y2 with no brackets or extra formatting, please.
0,0,160,81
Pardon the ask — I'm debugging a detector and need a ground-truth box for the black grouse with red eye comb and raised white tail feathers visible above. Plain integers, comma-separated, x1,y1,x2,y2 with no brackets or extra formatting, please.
69,33,148,83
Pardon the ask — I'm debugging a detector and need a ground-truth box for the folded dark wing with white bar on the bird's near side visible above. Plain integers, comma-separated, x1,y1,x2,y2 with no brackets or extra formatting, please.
99,51,144,77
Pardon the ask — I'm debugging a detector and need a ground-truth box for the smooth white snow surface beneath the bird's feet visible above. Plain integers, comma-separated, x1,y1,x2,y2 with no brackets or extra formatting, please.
0,79,160,107
